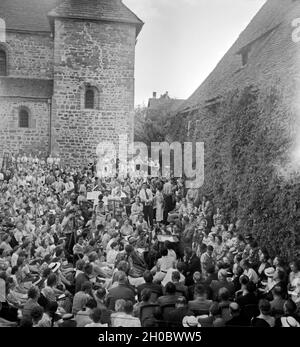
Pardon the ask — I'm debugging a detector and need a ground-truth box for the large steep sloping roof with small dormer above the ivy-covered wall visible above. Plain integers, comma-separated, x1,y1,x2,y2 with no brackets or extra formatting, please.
178,0,300,113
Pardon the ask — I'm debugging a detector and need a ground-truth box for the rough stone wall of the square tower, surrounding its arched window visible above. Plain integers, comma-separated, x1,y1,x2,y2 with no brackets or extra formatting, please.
52,19,136,164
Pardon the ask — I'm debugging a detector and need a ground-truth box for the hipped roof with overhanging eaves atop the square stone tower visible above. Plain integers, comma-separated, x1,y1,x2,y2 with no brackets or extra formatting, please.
49,0,144,35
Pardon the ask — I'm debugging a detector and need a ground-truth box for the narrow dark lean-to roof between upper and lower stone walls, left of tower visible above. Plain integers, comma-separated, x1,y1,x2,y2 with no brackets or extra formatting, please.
0,77,53,99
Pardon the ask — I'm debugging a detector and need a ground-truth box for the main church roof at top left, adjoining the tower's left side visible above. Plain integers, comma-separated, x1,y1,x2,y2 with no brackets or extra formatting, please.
0,0,59,32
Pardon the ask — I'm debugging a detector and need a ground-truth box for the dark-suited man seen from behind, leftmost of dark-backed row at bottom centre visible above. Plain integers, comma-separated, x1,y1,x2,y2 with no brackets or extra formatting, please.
106,271,135,310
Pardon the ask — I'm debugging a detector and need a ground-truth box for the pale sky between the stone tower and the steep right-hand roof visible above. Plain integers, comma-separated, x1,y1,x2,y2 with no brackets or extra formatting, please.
123,0,266,105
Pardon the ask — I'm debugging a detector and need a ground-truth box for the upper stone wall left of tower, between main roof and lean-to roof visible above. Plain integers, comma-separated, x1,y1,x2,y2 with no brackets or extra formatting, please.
6,32,53,79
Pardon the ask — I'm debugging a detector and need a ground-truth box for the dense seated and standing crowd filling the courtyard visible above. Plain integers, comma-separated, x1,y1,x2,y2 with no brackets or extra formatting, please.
0,156,300,327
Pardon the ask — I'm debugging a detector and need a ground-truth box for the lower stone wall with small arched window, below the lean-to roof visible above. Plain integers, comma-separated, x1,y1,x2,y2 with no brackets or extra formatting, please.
0,98,49,157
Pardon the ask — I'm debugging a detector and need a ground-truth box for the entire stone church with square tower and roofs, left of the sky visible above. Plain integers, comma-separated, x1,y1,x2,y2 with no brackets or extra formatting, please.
0,0,143,164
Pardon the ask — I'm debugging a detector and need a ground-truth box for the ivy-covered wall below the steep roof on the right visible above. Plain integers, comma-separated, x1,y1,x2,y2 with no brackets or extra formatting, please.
169,86,300,259
